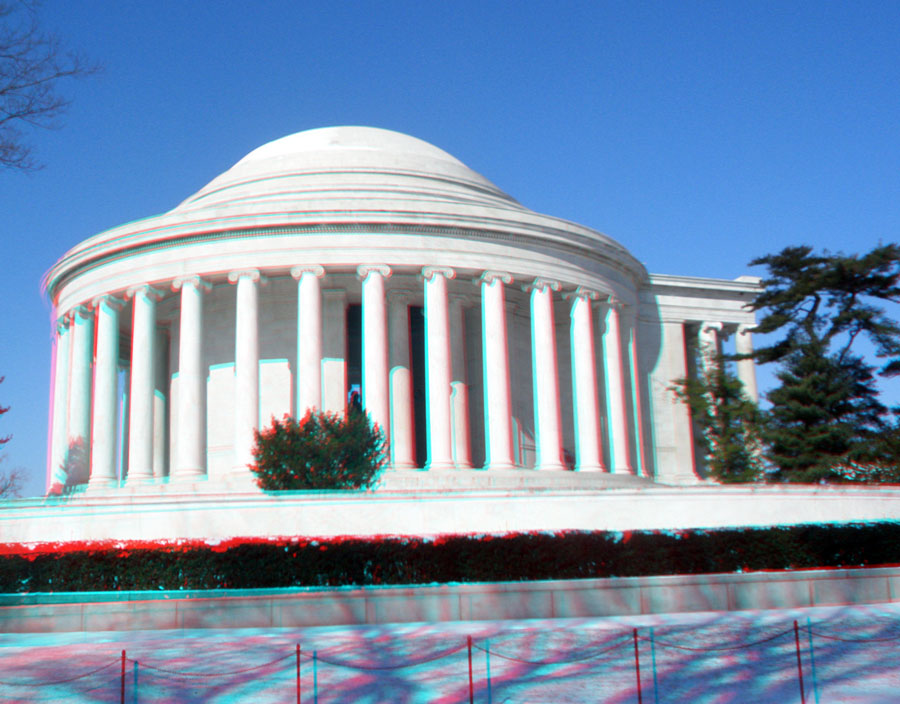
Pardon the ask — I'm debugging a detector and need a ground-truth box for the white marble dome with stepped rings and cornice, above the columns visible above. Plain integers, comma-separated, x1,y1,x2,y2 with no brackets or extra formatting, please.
46,127,646,312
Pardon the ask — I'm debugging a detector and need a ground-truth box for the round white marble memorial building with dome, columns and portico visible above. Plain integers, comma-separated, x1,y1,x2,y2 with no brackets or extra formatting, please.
44,127,760,495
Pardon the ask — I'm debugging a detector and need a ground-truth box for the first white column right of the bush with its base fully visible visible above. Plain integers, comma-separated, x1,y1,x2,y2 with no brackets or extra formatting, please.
422,266,456,470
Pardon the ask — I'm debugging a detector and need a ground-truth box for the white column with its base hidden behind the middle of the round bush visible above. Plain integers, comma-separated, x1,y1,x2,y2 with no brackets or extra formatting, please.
291,264,325,419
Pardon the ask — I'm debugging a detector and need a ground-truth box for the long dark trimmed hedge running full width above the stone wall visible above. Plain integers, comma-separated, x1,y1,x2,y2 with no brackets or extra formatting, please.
0,523,900,593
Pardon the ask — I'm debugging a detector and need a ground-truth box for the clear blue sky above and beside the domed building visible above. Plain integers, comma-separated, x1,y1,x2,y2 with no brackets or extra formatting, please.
0,0,900,494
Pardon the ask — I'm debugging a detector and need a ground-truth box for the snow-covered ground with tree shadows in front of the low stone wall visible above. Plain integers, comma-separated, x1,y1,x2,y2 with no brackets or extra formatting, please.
0,604,900,704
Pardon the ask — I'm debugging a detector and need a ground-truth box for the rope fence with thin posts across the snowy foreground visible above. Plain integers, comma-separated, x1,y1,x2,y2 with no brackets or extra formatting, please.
0,619,900,703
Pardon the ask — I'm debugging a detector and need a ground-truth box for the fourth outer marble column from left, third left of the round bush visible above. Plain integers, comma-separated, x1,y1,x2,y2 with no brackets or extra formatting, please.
128,285,161,484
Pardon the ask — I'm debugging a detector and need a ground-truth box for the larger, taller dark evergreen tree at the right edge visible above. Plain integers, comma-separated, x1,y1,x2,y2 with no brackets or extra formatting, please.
751,244,900,482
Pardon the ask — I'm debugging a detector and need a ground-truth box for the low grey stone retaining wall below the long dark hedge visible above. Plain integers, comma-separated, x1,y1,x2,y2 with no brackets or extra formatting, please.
0,567,900,633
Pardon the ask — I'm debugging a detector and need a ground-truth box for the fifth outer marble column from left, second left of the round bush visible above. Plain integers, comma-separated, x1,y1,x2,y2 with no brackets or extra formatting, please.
172,276,210,481
